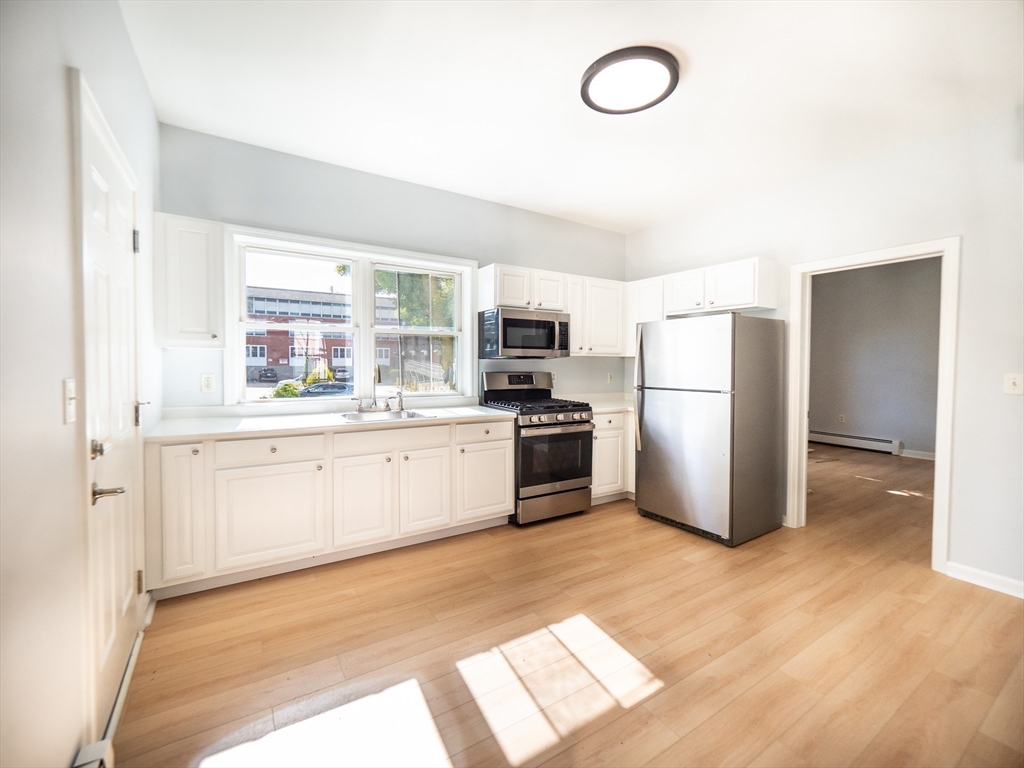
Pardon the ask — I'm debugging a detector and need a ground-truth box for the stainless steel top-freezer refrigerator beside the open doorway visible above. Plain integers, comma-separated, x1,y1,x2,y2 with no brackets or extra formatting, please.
635,312,785,547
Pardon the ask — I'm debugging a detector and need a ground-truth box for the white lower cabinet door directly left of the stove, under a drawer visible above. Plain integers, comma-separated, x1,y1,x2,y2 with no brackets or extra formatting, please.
456,440,515,522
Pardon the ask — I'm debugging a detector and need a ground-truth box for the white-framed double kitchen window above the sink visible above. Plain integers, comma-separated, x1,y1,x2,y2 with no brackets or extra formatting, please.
225,228,475,404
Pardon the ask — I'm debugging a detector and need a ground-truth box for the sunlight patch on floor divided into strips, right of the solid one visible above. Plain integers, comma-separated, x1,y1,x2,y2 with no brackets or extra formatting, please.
456,614,664,766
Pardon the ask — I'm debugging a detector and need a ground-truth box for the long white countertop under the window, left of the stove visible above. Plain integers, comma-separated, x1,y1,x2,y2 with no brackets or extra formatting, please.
145,406,515,442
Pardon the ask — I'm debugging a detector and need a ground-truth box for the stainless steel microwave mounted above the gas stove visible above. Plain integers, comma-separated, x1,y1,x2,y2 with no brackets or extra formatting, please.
478,306,569,360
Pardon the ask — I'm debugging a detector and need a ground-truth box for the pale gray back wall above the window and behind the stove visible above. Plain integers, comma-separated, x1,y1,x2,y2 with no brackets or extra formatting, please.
160,125,625,407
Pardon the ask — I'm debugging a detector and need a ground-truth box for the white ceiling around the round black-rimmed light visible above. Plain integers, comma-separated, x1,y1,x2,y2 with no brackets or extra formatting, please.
121,0,1024,232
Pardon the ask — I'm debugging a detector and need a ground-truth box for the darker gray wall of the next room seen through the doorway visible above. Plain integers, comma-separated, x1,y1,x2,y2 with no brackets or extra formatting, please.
810,258,942,454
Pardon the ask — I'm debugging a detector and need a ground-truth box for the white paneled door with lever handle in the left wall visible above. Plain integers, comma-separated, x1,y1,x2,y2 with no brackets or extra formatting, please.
77,73,141,736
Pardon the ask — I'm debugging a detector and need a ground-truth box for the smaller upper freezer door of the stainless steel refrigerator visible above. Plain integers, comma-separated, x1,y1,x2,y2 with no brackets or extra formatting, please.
637,312,734,392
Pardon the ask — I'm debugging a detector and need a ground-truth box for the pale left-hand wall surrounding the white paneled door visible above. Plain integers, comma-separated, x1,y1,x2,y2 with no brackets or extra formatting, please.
0,0,160,766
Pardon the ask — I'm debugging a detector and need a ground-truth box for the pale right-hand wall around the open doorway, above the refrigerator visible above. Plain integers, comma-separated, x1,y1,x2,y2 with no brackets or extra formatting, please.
626,110,1024,582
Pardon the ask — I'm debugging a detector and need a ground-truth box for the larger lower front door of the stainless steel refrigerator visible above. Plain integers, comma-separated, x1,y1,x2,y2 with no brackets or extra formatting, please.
636,389,732,539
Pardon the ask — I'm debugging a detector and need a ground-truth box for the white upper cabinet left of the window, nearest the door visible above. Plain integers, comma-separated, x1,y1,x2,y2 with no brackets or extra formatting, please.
154,213,224,347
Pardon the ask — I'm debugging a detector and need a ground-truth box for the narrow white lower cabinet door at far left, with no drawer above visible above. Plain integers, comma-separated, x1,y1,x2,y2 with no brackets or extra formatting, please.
160,443,206,582
